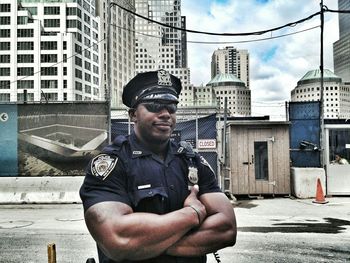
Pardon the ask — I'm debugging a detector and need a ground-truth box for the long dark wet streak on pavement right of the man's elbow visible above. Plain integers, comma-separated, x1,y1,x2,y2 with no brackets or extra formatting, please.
238,218,350,234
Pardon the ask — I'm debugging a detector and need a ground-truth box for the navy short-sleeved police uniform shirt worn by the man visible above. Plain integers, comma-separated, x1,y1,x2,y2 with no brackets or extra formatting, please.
80,134,220,263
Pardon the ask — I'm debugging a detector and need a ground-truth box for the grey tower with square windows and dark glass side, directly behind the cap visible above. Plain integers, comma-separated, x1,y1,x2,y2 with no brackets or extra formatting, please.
135,0,193,106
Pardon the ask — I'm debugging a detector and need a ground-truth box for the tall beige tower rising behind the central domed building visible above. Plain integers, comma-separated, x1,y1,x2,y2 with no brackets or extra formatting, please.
211,47,250,88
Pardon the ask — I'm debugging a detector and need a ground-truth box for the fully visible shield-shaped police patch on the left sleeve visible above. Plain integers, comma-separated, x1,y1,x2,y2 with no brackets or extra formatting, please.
91,154,118,180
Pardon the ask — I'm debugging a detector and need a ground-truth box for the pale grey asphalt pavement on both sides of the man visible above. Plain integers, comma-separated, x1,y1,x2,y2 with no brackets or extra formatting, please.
0,197,350,263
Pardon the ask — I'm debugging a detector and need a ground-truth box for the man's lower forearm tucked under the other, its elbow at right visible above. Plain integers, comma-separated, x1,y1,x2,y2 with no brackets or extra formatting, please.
166,213,236,256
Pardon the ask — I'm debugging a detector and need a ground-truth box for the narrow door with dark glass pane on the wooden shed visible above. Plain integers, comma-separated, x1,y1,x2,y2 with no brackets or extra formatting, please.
248,129,275,194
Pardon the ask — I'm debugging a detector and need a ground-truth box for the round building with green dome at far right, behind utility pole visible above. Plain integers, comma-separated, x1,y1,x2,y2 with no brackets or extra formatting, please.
291,69,350,119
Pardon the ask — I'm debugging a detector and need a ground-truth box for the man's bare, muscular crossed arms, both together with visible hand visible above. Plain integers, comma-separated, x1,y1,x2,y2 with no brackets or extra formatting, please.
85,189,237,261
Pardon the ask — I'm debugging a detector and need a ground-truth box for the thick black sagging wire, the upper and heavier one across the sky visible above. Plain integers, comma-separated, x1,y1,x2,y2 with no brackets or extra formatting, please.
110,2,321,36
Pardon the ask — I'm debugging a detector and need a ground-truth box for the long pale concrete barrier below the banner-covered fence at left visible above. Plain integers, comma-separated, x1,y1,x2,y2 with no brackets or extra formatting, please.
0,176,84,204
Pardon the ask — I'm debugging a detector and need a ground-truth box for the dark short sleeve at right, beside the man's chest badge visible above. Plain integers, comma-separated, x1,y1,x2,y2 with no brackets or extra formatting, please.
196,154,221,195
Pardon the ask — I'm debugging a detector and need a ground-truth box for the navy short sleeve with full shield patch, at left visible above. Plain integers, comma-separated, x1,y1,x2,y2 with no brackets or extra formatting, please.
80,154,131,211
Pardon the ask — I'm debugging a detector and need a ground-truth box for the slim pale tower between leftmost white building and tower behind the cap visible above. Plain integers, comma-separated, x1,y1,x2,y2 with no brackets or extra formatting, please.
96,0,135,108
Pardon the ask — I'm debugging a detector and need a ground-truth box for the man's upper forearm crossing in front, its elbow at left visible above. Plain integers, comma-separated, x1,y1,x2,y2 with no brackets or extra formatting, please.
89,203,198,261
